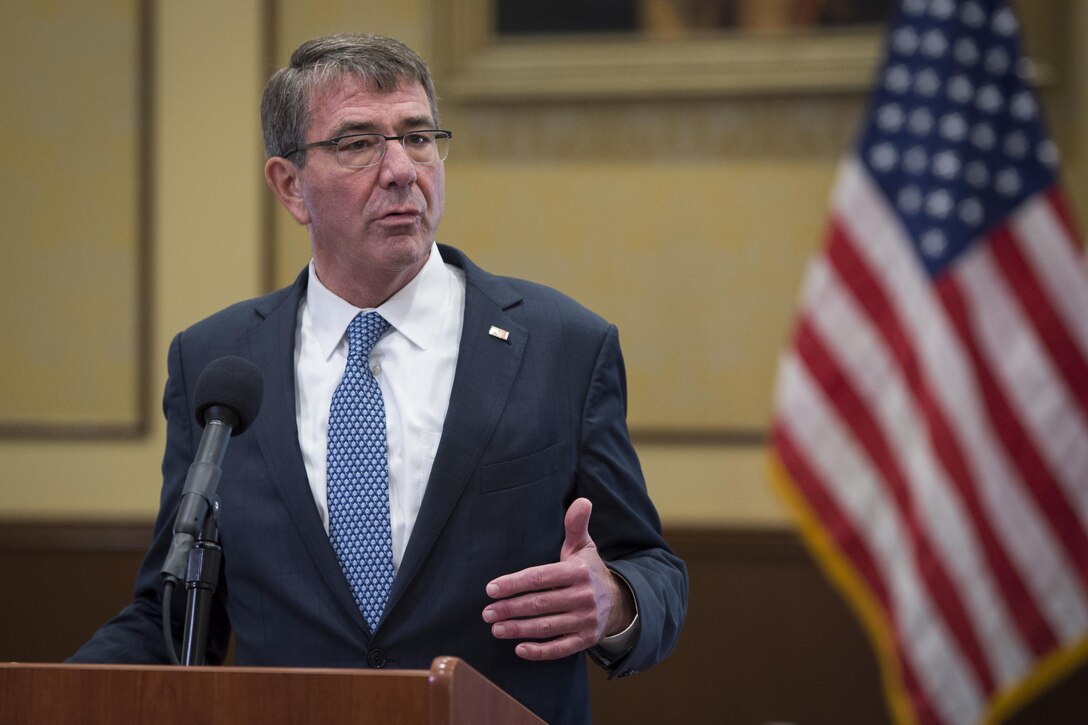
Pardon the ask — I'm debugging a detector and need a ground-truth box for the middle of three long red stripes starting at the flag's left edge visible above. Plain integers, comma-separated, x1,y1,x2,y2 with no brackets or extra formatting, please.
794,318,994,693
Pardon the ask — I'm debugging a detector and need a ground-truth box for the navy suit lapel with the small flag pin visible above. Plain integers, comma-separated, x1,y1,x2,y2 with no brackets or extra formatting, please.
386,246,529,612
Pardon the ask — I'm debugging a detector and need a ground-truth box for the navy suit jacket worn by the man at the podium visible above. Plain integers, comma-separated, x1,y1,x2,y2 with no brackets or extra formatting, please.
72,246,688,723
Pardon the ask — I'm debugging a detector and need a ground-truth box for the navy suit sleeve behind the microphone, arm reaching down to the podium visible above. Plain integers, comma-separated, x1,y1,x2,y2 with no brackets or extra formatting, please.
69,334,230,664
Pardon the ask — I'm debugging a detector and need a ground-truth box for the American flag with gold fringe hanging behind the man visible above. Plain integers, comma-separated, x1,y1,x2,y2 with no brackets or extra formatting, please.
772,0,1088,724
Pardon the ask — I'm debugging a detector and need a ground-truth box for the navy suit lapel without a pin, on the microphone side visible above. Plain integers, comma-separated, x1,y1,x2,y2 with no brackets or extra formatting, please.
249,270,367,629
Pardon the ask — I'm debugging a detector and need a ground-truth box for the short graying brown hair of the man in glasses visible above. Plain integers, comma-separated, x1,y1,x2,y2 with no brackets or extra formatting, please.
261,33,438,168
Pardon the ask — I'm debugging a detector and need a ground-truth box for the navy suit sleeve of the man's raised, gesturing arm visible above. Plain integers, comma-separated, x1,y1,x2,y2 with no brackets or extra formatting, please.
578,325,688,677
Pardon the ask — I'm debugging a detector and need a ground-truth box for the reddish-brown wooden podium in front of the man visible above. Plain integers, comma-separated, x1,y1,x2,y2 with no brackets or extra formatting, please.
0,658,543,725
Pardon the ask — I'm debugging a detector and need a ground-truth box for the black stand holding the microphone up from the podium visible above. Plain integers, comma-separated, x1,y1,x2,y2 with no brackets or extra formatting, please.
181,499,223,666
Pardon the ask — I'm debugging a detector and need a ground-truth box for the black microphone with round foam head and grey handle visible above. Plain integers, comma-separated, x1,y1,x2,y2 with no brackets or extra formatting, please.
161,356,264,582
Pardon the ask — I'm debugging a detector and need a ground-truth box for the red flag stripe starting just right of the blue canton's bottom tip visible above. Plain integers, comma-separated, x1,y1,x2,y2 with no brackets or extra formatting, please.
937,277,1088,613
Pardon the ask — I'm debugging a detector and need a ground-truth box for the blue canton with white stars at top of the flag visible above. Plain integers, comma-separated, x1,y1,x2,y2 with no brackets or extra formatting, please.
857,0,1058,277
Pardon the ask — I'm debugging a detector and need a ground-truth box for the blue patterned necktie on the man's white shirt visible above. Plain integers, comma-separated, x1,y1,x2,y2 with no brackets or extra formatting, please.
326,312,393,629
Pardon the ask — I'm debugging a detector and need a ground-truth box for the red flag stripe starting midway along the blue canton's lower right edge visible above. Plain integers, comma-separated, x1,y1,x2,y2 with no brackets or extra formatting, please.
990,226,1088,420
